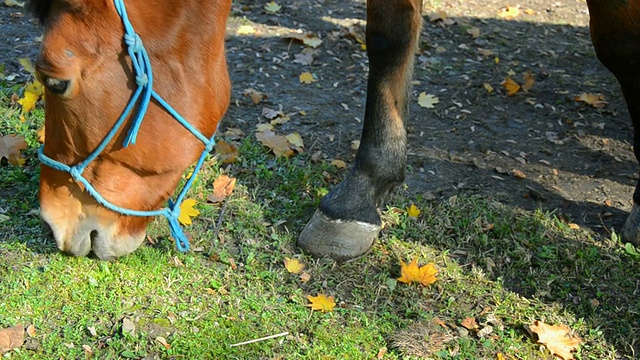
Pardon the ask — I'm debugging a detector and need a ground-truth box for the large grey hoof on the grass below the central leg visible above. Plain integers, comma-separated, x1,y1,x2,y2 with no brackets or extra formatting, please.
298,210,381,262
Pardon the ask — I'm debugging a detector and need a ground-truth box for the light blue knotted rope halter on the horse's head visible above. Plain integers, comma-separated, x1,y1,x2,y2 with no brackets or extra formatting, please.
38,0,215,252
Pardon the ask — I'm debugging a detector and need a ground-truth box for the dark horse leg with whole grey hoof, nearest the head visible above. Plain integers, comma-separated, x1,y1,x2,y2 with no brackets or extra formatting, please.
298,0,422,261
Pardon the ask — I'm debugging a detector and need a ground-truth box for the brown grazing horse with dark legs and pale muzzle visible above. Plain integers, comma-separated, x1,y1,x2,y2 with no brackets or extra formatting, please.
31,0,640,259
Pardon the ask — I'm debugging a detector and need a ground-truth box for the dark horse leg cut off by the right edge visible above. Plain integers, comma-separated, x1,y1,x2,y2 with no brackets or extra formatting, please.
587,0,640,245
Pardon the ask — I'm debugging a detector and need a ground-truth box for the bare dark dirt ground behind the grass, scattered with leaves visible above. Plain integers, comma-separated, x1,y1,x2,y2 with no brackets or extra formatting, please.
0,0,638,239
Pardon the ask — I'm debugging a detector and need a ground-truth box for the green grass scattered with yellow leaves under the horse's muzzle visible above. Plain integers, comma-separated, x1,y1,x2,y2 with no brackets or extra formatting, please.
0,82,640,359
